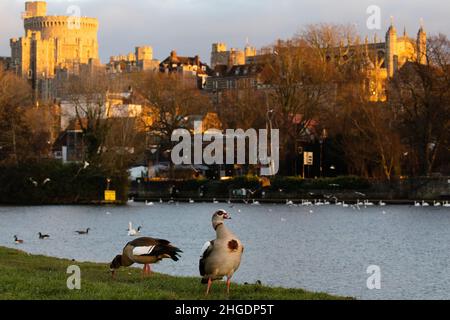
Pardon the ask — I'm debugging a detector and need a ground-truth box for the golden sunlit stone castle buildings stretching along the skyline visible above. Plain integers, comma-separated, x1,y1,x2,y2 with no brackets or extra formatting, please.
7,1,427,102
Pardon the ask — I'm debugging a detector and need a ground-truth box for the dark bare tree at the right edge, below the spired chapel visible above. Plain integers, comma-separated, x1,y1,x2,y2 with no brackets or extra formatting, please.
389,35,450,175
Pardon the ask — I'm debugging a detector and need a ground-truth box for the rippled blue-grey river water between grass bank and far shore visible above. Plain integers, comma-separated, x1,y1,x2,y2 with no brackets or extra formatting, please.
0,203,450,299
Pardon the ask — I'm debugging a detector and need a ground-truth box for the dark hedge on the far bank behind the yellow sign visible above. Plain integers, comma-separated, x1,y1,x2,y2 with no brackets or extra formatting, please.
0,161,128,205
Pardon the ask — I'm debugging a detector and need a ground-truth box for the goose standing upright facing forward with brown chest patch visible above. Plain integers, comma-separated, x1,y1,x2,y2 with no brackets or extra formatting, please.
199,210,244,295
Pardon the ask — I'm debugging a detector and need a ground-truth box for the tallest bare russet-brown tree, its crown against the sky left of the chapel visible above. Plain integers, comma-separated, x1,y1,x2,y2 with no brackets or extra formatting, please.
263,25,354,173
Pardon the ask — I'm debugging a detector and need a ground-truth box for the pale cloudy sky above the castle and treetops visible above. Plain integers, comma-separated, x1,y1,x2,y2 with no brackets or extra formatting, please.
0,0,450,63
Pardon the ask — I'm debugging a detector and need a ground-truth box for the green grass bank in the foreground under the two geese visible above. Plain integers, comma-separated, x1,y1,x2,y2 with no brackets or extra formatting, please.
0,247,350,300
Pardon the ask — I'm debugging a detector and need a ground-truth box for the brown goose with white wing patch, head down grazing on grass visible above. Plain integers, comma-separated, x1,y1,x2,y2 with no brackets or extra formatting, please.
110,238,183,278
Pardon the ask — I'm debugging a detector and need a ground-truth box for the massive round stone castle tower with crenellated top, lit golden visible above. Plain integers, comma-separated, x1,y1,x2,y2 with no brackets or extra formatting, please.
10,1,100,96
